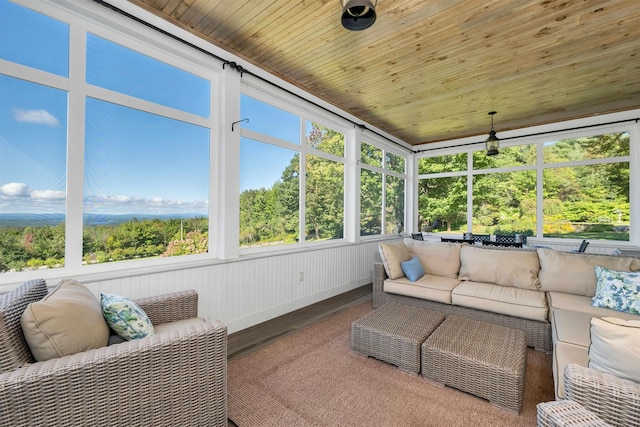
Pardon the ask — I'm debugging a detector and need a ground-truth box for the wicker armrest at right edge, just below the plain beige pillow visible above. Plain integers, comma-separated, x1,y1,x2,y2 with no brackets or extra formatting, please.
564,363,640,426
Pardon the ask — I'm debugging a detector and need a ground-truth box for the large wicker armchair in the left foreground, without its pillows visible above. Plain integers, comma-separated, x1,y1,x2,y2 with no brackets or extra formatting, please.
0,280,227,427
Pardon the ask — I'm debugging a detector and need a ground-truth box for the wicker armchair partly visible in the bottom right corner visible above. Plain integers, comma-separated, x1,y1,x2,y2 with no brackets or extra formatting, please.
538,364,640,427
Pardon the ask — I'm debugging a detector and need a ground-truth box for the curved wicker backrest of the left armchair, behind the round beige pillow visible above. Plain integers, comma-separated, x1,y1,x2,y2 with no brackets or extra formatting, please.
0,279,47,373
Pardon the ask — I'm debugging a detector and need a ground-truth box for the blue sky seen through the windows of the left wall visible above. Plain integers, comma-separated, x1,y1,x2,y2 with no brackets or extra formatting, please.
0,0,300,215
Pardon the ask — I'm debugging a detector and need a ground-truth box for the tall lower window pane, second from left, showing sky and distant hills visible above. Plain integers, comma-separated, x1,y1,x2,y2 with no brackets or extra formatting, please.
83,98,209,263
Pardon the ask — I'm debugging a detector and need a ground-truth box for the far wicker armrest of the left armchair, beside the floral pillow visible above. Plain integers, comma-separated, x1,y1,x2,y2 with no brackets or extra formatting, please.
136,289,198,325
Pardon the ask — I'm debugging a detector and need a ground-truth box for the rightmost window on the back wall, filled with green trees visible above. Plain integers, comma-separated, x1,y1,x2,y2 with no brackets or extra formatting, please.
543,132,630,240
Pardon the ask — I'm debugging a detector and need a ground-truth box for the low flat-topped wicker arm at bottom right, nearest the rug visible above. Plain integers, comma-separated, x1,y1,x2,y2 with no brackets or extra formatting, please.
538,400,609,427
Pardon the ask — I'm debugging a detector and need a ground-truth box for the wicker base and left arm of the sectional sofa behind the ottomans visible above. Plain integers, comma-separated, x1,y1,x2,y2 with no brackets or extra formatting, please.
373,262,553,353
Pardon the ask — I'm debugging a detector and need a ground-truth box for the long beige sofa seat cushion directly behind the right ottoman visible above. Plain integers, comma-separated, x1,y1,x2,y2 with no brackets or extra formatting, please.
451,281,548,322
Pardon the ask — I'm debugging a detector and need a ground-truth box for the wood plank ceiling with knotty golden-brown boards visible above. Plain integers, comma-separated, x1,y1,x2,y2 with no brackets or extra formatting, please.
130,0,640,145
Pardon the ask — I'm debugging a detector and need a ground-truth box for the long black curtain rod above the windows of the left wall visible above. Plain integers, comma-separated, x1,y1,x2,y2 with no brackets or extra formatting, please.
93,0,415,154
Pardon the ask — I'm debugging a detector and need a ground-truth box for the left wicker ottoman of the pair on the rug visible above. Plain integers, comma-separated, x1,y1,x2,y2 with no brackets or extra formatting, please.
351,303,445,375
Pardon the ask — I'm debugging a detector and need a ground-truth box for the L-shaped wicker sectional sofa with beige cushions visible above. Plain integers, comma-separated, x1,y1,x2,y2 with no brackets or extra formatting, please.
373,238,640,412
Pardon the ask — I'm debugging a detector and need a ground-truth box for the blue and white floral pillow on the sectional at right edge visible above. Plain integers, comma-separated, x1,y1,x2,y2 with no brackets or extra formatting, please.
591,266,640,314
